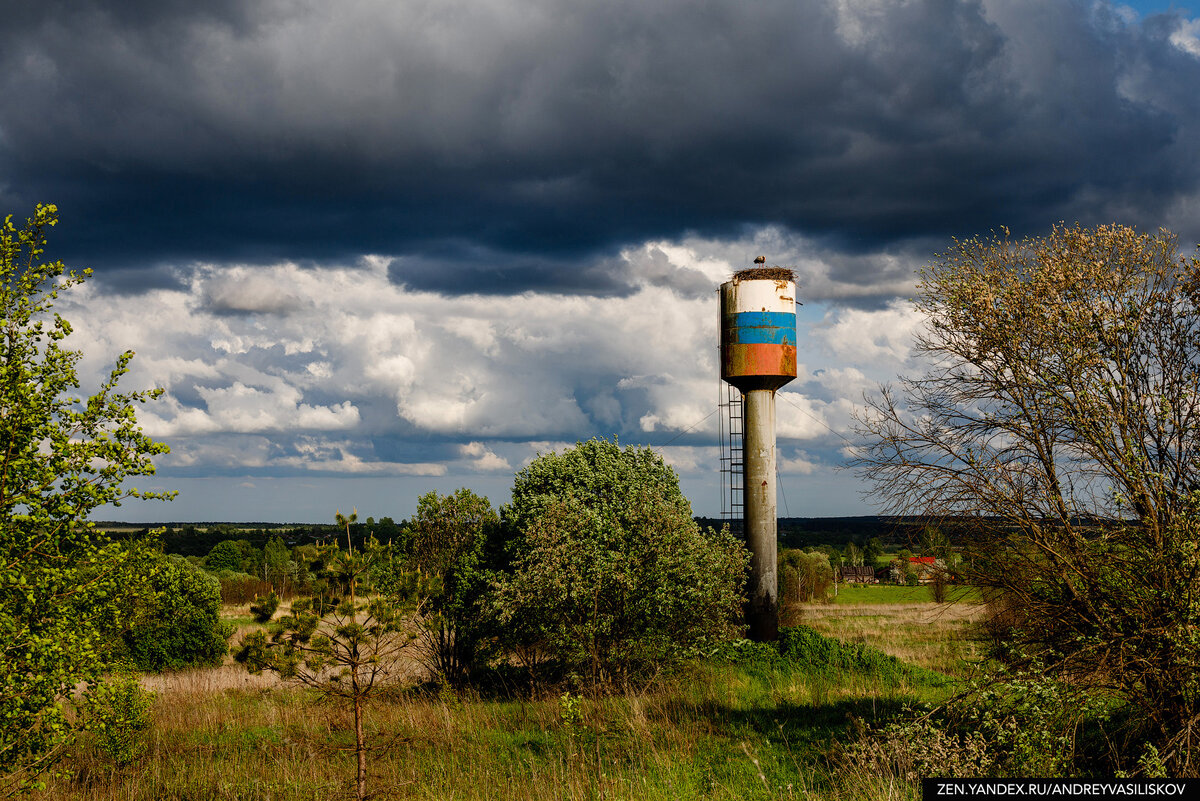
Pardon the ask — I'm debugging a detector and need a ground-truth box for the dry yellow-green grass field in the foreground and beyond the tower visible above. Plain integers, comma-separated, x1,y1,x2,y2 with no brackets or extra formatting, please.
38,588,978,801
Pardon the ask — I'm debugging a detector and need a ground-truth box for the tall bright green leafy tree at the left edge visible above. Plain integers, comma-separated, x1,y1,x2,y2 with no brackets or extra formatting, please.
0,205,167,790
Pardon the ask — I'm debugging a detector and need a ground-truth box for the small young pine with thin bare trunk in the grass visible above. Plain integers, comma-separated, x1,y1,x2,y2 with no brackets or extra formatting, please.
235,532,415,799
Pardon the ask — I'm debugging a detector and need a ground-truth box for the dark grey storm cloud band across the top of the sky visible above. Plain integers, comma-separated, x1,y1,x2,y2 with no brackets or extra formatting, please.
0,0,1200,294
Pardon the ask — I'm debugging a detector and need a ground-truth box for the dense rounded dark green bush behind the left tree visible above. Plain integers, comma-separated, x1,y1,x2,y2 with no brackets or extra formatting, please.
120,555,233,671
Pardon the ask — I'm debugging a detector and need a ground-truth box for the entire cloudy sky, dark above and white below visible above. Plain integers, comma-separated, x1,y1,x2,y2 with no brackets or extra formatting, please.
0,0,1200,522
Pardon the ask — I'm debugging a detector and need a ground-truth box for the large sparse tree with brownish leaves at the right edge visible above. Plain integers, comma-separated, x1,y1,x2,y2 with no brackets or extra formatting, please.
859,225,1200,775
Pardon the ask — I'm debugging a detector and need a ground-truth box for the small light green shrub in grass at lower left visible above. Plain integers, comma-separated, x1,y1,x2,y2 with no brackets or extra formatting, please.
79,673,155,767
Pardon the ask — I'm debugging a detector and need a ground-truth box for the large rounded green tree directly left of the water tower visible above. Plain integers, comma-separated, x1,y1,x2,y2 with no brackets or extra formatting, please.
494,439,748,685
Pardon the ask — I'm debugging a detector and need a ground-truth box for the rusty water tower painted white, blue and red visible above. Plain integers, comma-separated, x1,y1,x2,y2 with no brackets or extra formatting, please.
721,257,796,642
